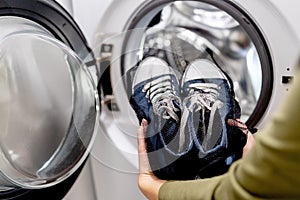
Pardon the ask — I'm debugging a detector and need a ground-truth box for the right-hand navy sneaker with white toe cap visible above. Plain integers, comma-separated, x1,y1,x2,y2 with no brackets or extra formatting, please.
181,59,247,178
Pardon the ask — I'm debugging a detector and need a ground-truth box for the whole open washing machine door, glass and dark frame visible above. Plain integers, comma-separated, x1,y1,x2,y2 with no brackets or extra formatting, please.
0,0,100,199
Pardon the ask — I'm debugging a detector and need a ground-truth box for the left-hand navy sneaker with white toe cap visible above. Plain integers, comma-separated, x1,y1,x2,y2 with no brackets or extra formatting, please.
130,57,192,179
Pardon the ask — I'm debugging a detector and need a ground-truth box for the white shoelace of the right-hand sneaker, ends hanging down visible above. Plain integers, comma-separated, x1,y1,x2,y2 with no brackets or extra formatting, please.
179,83,223,151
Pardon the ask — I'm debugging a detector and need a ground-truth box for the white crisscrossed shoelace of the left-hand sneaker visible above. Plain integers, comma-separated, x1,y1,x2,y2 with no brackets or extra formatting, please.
143,76,180,122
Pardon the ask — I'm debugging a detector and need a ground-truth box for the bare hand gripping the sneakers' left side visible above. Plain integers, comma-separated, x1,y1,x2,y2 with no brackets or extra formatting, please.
138,119,166,200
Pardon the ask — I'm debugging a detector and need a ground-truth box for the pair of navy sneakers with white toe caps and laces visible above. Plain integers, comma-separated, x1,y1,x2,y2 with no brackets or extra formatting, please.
130,57,246,180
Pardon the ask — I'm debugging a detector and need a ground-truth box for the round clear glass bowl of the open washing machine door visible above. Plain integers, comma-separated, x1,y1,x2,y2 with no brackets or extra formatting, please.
0,16,99,191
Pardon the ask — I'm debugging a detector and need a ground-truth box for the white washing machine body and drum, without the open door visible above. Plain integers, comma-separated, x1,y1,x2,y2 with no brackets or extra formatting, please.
68,0,300,200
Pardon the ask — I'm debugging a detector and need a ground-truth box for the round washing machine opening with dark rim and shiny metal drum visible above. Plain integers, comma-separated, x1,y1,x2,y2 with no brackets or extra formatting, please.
121,0,273,126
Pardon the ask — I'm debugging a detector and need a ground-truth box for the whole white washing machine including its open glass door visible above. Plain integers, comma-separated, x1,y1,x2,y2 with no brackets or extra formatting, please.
0,0,300,200
